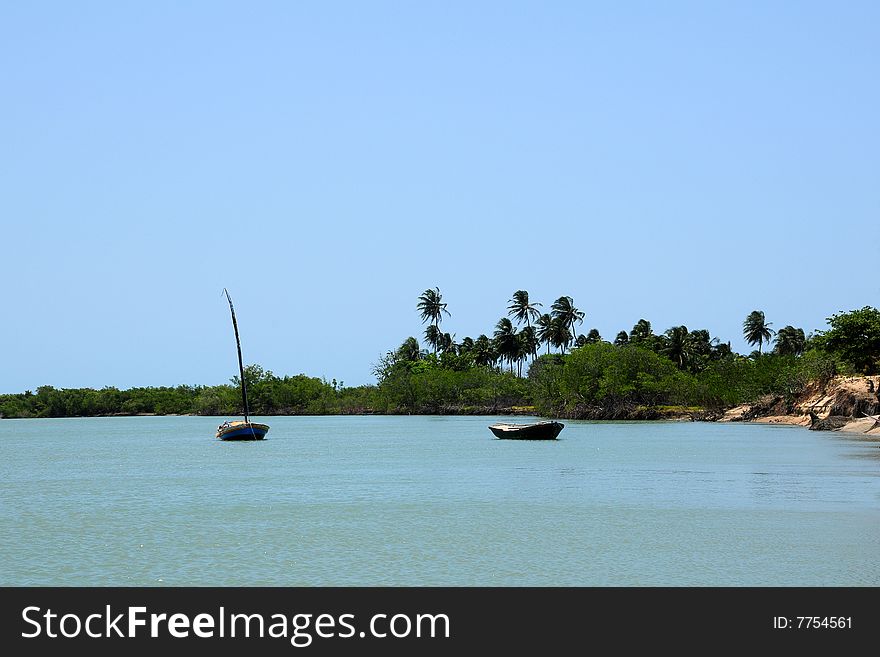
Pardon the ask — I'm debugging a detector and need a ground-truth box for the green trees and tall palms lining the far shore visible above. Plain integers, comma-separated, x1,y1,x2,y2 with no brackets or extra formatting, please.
0,288,880,420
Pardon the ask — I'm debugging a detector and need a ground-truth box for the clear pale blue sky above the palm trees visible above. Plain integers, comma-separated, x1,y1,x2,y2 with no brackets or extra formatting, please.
0,0,880,392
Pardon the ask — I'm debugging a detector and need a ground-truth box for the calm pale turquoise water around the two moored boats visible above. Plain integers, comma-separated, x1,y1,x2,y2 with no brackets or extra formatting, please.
0,416,880,586
